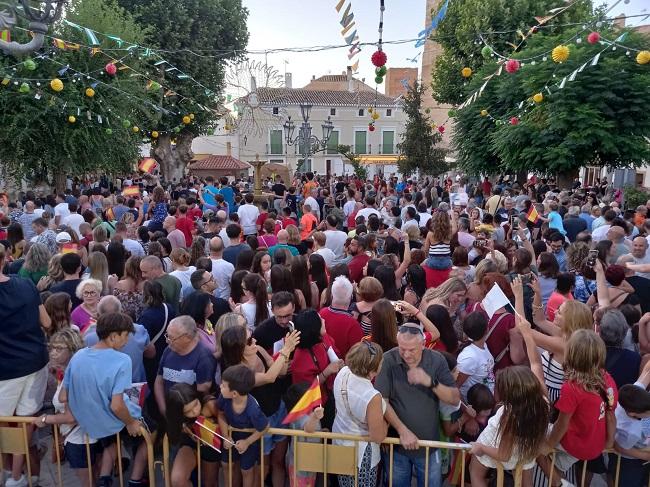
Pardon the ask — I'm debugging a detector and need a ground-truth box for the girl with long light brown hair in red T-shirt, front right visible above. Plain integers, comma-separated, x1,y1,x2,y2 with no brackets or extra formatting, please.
537,329,617,485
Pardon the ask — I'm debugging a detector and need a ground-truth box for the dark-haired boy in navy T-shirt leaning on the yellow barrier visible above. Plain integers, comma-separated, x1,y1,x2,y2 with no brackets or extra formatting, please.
217,364,269,487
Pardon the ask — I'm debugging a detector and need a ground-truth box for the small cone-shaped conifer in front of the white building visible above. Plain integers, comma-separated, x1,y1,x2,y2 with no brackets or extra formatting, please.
397,81,447,176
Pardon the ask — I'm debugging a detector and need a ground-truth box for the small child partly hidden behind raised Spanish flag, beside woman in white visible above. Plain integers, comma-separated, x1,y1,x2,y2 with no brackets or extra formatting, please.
284,382,325,487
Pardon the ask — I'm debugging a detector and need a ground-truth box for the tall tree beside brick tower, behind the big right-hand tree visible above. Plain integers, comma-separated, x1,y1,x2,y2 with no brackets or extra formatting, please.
431,0,591,105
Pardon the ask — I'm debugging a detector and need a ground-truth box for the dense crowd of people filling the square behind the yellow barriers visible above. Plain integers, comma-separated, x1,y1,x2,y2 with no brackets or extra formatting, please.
0,173,650,487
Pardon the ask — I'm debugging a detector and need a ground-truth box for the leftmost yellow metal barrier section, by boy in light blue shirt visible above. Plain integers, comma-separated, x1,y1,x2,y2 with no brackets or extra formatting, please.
0,416,156,487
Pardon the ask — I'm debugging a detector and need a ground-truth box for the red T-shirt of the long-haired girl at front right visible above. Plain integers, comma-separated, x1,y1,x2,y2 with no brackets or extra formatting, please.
555,371,618,460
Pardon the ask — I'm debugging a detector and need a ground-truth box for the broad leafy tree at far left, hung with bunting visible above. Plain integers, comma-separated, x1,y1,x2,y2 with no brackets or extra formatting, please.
0,0,147,190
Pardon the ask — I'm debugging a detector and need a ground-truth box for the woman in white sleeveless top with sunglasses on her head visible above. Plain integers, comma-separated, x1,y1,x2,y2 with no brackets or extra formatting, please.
332,341,388,487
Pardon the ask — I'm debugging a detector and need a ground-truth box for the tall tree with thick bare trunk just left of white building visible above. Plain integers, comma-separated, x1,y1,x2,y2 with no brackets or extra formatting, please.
118,0,248,180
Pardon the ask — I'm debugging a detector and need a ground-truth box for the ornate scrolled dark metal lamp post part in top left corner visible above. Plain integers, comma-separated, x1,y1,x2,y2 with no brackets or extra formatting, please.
0,0,65,56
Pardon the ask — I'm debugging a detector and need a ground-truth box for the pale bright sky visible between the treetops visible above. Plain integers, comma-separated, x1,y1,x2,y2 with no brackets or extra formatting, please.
243,0,650,93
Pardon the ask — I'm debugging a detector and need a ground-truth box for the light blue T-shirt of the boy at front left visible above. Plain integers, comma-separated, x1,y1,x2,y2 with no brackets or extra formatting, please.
63,348,142,439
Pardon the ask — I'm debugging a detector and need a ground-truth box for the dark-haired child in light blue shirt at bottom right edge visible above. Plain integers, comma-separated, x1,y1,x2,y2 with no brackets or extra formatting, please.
609,362,650,487
